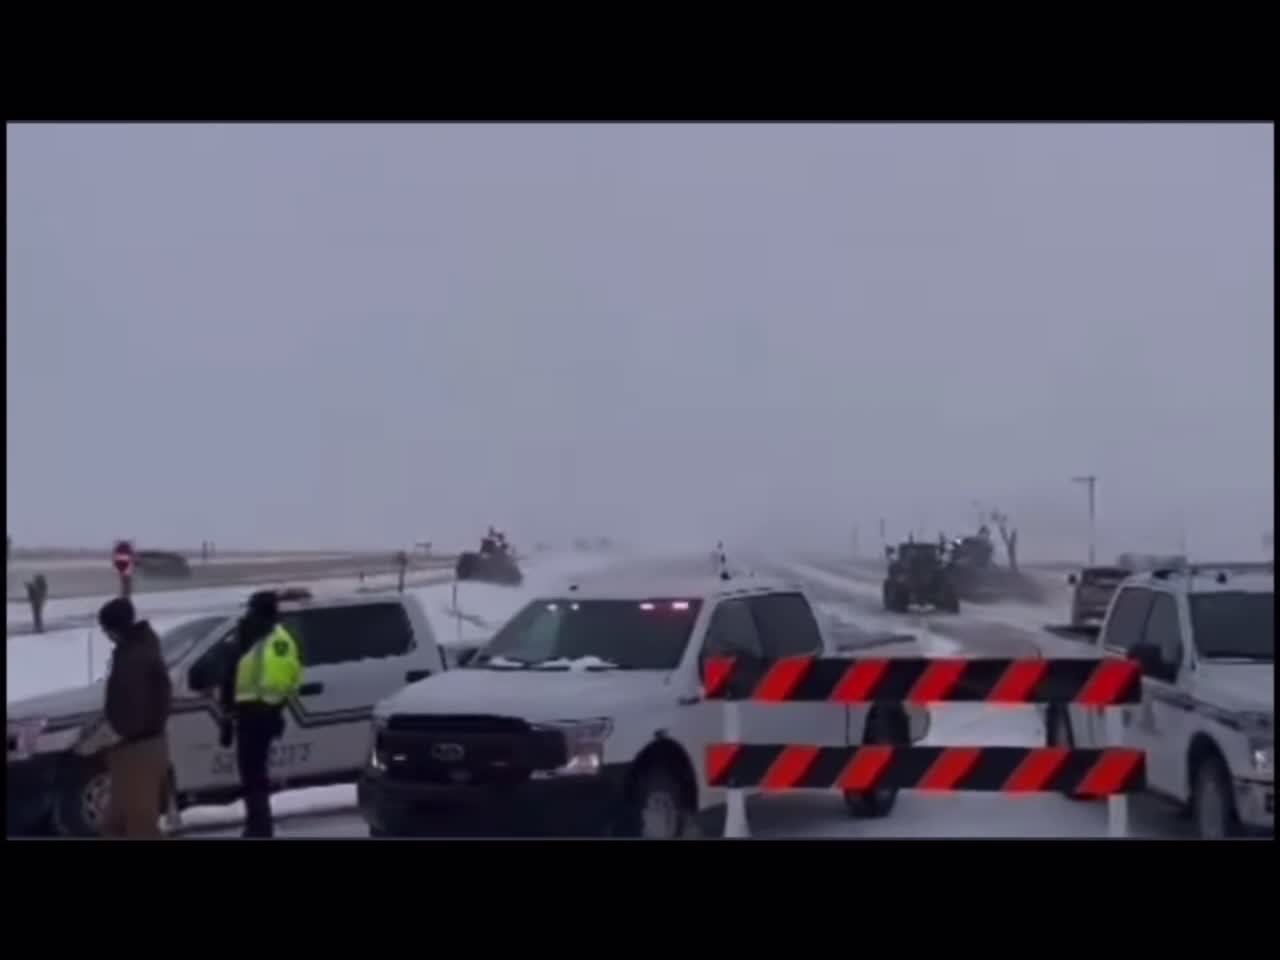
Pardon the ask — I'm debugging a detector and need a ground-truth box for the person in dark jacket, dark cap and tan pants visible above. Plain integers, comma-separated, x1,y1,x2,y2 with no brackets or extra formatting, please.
97,596,173,837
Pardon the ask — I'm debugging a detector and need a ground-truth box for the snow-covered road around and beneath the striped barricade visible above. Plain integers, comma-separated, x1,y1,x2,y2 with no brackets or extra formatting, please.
149,558,1190,838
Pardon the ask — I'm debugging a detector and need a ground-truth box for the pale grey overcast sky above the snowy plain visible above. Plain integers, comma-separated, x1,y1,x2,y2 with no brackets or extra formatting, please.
6,125,1275,557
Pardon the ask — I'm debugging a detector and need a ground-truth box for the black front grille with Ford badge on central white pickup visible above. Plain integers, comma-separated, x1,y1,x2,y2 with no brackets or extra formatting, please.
378,714,568,786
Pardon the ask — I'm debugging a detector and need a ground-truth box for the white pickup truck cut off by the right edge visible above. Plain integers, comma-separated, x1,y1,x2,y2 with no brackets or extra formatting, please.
1046,564,1275,837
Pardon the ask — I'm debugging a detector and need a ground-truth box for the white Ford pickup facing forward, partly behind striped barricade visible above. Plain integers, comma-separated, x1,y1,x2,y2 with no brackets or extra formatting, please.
358,576,928,837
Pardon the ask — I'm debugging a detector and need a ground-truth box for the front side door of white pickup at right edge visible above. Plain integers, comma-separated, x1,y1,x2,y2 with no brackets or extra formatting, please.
1129,594,1194,799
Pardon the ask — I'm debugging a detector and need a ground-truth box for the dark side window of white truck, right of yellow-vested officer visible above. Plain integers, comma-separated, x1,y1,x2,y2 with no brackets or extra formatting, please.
282,603,413,667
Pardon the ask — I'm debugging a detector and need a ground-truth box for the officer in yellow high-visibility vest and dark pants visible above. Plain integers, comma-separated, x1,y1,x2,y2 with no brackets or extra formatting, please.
220,590,302,837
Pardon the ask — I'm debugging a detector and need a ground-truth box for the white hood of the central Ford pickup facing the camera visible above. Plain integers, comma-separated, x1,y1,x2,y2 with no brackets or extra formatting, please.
375,668,678,723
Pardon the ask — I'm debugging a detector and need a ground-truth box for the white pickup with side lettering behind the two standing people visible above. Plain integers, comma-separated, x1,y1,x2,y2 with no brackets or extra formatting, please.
6,591,445,836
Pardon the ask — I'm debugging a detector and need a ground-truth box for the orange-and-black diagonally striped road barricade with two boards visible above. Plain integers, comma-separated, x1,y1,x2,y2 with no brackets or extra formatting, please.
705,657,1146,837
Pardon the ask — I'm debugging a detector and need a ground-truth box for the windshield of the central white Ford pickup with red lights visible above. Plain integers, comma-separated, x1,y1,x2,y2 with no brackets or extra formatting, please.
468,598,701,671
